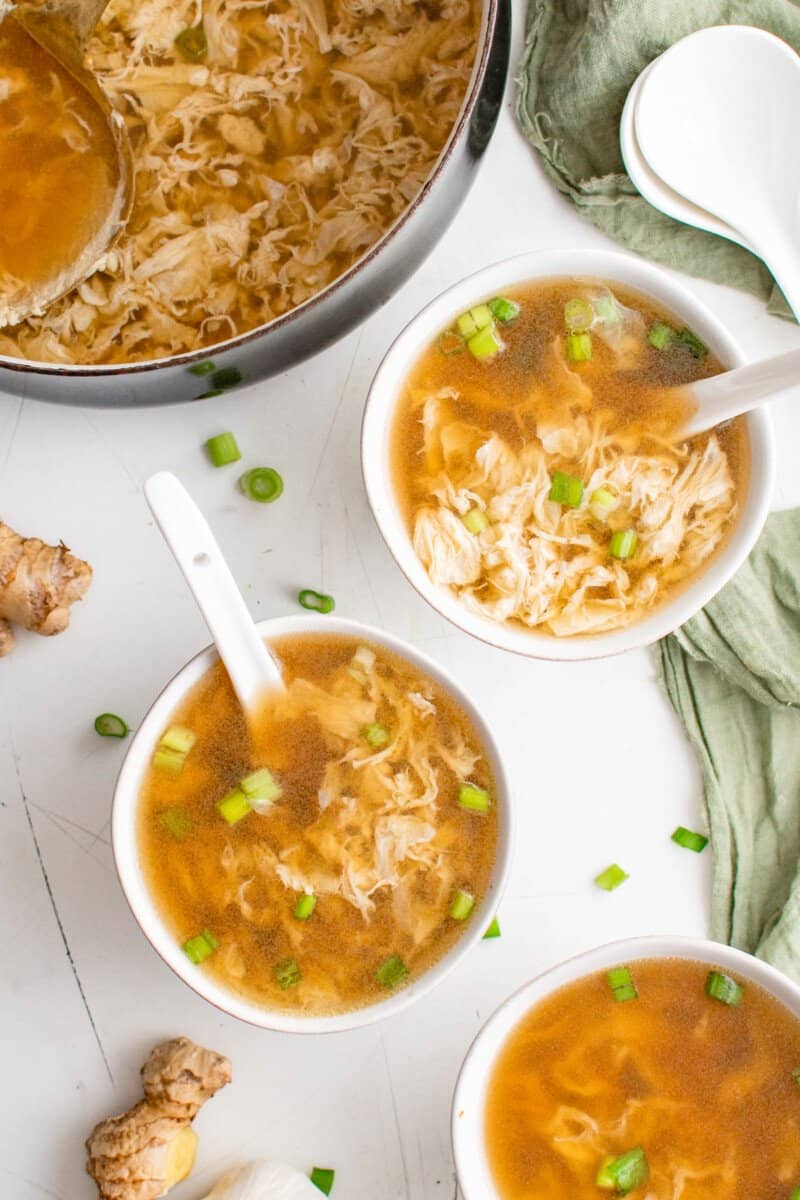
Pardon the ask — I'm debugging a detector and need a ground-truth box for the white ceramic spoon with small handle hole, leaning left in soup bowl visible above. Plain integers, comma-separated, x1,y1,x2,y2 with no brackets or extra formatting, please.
144,470,284,721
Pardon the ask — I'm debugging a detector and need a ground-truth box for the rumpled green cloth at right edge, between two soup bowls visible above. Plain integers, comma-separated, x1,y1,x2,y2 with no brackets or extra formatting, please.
655,509,800,980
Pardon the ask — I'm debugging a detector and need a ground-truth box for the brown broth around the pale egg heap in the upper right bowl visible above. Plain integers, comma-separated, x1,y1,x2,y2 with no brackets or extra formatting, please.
391,278,750,634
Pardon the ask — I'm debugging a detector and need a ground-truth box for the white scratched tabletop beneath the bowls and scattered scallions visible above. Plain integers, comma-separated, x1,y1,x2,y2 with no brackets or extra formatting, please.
0,11,800,1200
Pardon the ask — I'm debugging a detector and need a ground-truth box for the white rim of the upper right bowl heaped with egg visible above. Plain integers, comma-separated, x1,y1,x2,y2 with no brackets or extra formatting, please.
361,248,775,661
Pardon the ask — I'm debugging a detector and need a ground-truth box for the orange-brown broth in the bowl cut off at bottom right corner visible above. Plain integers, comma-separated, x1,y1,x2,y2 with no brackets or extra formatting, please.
486,959,800,1200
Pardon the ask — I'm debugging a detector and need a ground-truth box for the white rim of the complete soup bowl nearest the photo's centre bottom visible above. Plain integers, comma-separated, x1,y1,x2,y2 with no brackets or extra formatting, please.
112,614,515,1033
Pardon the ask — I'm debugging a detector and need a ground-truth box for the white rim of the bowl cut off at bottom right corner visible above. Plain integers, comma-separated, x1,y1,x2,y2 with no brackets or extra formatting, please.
450,934,800,1200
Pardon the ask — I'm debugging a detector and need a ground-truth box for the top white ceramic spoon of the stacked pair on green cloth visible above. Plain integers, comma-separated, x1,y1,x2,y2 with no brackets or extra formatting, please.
634,25,800,314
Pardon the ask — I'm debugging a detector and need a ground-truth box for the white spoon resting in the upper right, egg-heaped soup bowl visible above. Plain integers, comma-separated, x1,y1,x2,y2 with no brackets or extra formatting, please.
680,350,800,437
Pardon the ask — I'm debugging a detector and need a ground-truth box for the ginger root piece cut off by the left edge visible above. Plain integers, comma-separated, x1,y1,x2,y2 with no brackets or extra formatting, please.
0,521,91,658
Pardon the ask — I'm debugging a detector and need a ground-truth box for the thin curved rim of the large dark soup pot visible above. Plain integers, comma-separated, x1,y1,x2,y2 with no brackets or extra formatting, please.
0,0,504,379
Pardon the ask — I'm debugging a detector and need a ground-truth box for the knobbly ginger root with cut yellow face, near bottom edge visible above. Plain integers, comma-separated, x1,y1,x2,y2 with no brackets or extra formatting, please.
86,1038,230,1200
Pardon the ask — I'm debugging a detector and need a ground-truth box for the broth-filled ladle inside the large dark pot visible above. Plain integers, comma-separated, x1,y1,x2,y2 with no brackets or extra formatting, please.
0,0,133,326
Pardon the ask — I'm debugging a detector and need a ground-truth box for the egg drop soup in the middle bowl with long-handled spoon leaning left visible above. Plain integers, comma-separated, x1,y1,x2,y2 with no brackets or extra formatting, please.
139,635,498,1015
